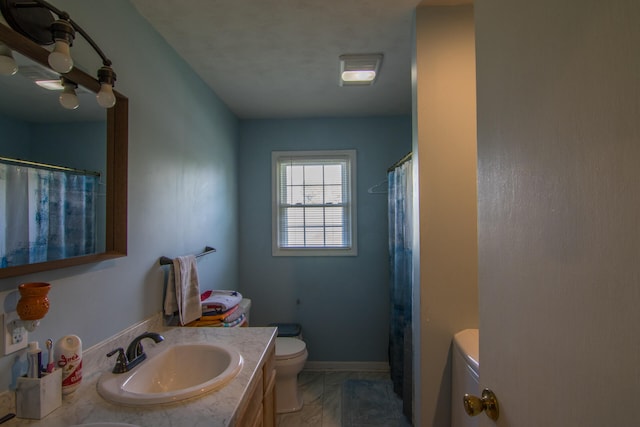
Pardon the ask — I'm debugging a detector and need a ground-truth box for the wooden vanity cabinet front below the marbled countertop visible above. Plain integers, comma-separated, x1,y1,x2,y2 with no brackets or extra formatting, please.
234,340,276,427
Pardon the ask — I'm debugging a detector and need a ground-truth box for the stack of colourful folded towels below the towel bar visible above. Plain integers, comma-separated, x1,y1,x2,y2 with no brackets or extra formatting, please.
187,290,246,328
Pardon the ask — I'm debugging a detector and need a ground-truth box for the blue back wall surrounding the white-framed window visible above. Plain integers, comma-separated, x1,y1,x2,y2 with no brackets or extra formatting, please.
239,116,411,361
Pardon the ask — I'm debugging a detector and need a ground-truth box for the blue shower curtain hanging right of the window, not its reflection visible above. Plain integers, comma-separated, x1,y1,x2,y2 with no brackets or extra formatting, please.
387,154,413,419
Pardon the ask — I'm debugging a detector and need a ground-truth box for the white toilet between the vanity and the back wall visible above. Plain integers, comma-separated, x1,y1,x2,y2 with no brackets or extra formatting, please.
273,324,309,414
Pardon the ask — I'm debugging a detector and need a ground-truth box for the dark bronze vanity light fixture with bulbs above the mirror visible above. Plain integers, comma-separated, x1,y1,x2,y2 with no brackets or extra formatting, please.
0,0,116,108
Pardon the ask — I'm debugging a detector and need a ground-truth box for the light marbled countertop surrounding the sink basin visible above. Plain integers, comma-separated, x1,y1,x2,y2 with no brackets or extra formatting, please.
8,327,276,427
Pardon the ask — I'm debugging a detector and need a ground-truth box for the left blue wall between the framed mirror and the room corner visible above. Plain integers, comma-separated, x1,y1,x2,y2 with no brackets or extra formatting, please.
0,0,239,390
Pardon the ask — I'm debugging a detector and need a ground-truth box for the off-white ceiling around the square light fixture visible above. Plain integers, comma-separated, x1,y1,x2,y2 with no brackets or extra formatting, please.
131,0,420,118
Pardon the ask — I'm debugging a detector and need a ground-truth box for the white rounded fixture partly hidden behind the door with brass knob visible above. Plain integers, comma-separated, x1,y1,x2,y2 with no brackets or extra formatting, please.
451,329,481,427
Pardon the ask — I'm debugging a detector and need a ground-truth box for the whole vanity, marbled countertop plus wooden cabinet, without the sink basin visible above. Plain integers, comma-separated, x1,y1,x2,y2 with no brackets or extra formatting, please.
0,316,276,427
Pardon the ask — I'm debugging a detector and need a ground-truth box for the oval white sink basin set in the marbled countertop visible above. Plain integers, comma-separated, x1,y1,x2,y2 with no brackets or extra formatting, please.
98,342,243,406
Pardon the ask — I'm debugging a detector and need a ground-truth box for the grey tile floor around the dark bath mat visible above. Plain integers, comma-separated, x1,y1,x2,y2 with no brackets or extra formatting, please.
276,371,396,427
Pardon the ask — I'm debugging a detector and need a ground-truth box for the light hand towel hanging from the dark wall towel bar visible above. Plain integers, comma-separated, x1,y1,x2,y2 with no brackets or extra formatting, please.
165,255,202,325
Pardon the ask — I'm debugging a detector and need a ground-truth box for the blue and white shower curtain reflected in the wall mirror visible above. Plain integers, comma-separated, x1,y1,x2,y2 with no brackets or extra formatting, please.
0,163,99,267
